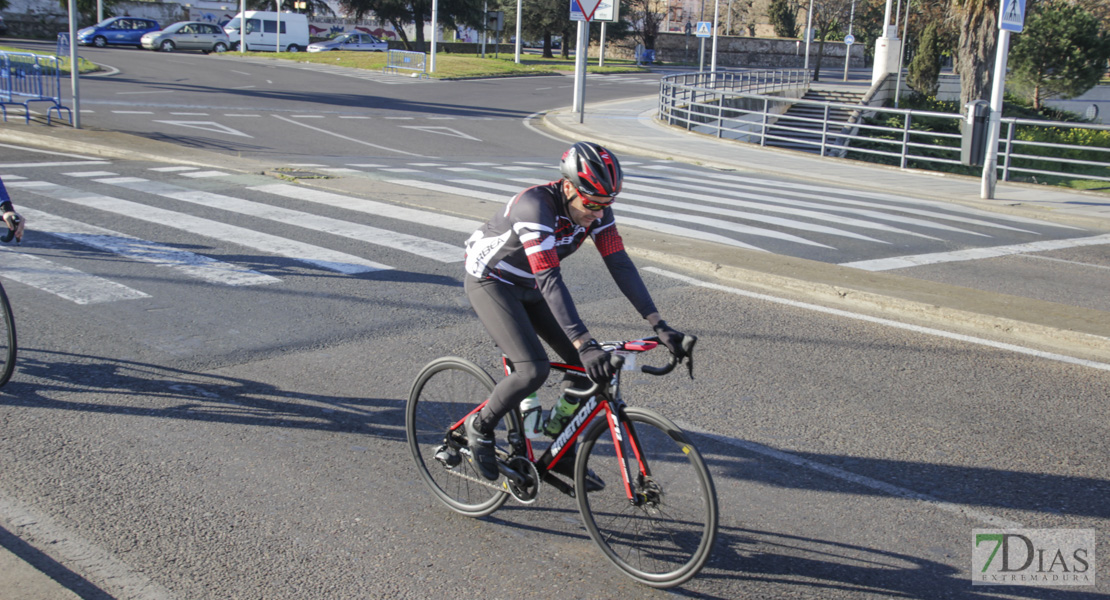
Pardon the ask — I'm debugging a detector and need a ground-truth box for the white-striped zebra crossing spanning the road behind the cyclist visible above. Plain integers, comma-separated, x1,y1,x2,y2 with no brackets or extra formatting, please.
0,160,1090,305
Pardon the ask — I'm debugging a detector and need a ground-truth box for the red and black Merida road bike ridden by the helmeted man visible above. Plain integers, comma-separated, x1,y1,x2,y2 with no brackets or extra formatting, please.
405,335,717,588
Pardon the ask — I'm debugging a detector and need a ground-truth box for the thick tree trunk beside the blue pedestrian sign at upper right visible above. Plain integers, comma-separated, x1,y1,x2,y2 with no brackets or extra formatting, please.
952,0,999,106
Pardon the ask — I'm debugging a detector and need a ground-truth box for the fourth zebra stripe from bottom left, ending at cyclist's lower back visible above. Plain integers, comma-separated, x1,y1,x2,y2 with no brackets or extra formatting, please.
97,177,463,263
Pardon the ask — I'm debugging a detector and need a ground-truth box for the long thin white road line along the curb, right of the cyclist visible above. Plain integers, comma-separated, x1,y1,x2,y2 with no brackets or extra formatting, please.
644,266,1110,370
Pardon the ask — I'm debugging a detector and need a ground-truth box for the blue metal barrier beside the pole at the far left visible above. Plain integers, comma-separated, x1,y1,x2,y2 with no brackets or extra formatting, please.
0,52,73,125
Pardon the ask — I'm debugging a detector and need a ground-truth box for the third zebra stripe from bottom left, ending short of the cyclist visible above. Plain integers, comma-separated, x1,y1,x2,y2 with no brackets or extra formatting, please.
12,182,393,275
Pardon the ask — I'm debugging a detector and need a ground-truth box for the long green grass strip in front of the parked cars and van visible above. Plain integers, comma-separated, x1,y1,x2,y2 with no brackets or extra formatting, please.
223,50,647,79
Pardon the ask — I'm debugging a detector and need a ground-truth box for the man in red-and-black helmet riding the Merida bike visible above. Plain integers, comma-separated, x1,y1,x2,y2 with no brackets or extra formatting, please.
464,142,683,487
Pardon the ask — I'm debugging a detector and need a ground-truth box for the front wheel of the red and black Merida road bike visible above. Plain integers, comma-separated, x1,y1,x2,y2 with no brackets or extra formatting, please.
575,407,717,588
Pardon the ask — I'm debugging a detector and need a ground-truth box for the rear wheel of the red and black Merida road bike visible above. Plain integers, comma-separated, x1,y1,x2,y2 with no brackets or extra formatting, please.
405,356,508,517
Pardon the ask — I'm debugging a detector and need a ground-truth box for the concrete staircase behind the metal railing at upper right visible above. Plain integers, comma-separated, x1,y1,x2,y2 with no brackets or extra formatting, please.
766,84,867,154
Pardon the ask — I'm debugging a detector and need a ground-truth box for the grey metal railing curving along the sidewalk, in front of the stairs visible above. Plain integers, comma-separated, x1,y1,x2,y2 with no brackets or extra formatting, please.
659,71,1110,187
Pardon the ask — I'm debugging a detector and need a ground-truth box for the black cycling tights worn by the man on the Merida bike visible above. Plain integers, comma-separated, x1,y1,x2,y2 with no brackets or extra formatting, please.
464,275,582,434
